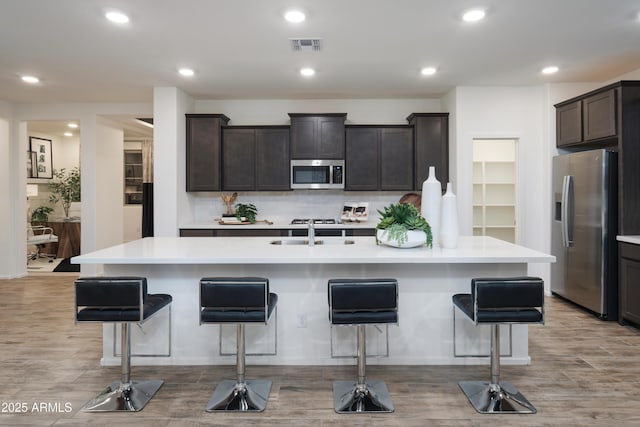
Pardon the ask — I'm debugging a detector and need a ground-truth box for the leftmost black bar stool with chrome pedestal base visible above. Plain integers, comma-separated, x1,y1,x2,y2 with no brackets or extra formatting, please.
75,277,172,412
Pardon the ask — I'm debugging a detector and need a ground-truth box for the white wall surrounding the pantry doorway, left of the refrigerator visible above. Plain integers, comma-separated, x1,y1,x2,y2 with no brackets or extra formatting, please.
450,86,552,284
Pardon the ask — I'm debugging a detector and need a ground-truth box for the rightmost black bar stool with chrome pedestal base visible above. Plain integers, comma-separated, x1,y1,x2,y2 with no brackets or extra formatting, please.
453,277,544,414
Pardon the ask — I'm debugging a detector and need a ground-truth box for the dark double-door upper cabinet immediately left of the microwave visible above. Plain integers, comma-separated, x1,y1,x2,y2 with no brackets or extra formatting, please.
222,126,290,191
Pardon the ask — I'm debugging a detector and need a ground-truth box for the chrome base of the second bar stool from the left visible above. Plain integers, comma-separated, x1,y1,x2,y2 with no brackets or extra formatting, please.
206,380,271,412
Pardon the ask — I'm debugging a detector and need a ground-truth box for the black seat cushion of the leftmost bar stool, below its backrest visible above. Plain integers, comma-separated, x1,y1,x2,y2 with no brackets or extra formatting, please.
77,294,172,322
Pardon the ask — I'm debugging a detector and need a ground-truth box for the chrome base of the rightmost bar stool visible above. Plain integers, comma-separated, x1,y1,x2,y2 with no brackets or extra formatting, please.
458,381,537,414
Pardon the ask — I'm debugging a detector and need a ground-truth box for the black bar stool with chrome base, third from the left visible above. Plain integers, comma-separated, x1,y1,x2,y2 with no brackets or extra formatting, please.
328,279,398,414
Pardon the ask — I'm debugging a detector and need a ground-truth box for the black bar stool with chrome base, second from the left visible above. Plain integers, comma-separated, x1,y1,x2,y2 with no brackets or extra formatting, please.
200,277,278,412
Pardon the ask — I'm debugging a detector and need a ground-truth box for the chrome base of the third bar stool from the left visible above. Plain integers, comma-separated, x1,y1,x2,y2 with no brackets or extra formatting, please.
333,381,394,414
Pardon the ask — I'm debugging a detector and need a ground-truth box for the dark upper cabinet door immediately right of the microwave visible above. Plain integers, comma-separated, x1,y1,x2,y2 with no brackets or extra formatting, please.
344,128,380,191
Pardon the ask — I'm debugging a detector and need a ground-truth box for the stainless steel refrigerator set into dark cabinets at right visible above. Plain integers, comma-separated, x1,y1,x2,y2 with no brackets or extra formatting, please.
550,150,618,320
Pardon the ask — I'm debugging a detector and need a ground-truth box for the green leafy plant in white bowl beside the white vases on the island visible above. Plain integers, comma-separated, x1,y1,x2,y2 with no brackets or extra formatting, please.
376,203,433,248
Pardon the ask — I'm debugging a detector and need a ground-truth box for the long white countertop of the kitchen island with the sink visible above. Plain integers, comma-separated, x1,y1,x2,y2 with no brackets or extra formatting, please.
71,236,555,264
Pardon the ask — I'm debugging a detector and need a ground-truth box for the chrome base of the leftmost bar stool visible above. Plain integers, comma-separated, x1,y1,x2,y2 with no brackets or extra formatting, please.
82,380,164,412
